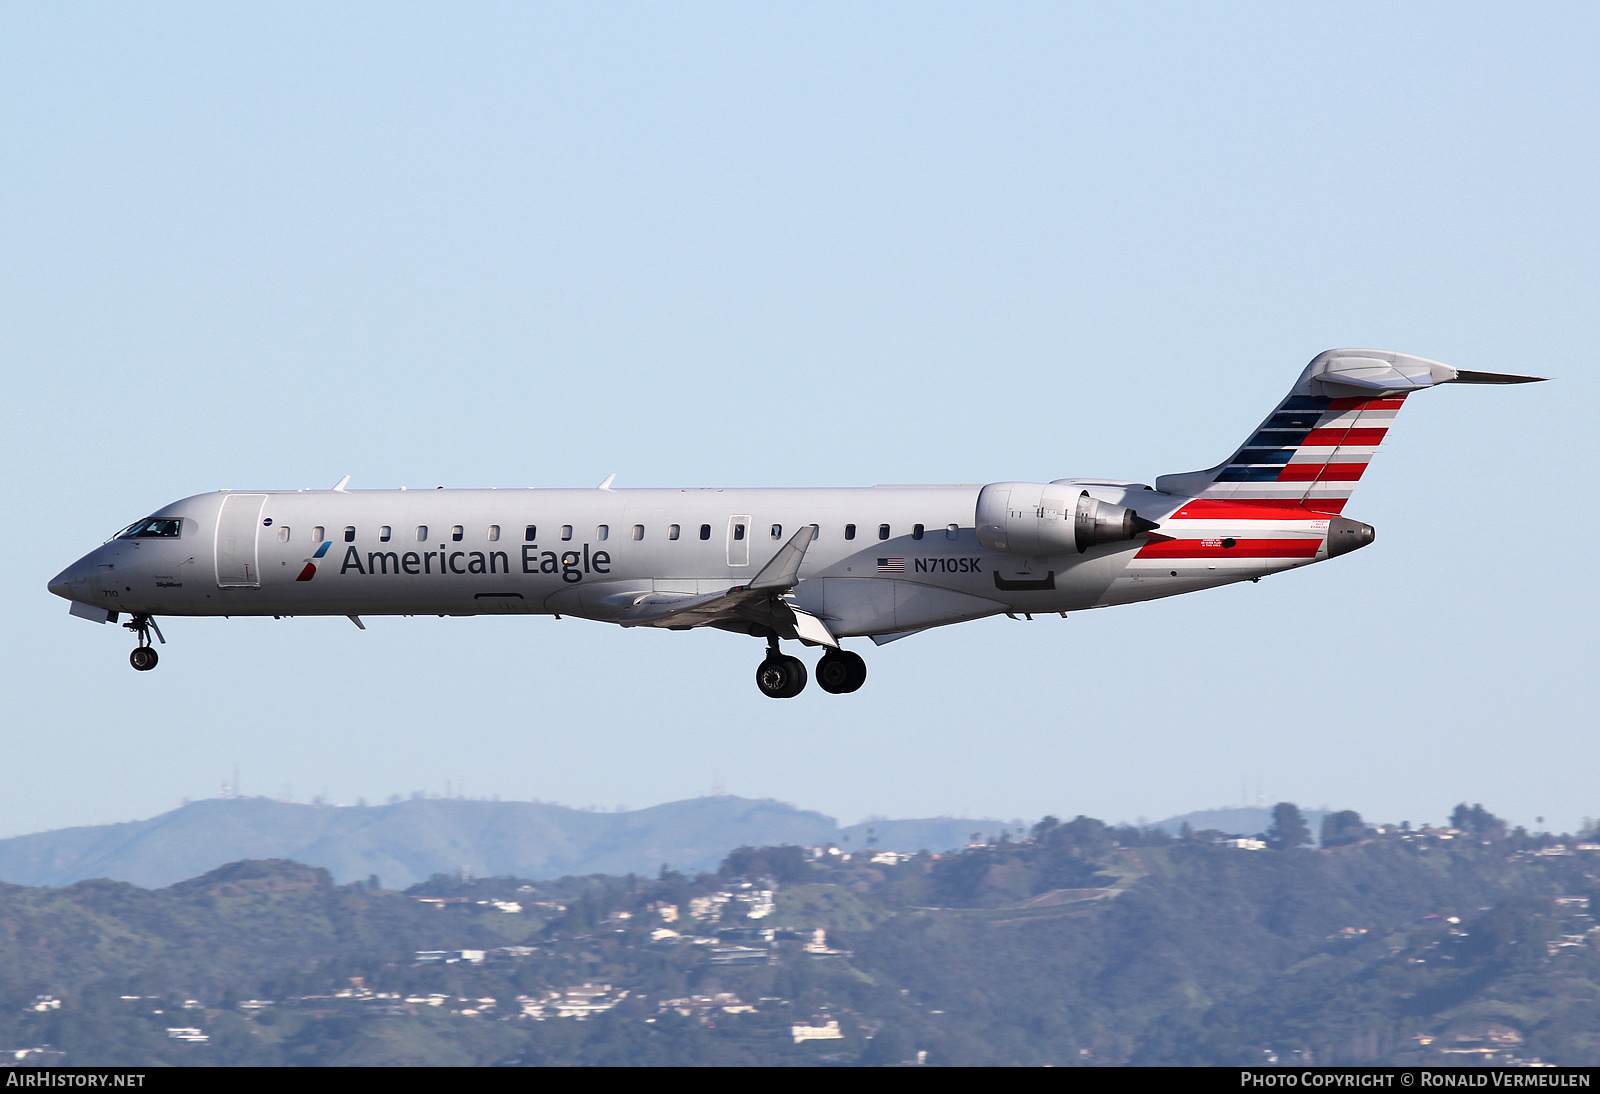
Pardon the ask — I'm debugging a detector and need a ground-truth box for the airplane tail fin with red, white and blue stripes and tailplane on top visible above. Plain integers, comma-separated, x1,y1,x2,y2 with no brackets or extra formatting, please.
1155,349,1544,513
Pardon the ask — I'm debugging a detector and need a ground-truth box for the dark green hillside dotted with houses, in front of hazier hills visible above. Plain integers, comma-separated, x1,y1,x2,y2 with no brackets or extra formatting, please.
0,809,1600,1065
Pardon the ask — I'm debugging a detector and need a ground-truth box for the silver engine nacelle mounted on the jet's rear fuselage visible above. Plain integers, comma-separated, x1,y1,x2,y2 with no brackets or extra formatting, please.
976,483,1158,557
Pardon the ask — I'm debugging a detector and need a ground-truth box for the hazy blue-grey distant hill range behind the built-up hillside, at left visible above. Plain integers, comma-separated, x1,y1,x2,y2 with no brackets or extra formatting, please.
0,795,1000,888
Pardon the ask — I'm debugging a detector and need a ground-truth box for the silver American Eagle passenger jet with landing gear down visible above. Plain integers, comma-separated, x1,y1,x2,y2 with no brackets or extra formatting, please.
50,349,1546,699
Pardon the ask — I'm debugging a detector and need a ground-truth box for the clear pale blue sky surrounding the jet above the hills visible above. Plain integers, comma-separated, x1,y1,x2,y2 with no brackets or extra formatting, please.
0,3,1600,835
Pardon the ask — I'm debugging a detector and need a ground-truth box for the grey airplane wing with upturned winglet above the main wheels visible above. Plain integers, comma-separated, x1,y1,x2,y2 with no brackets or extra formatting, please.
618,525,838,648
